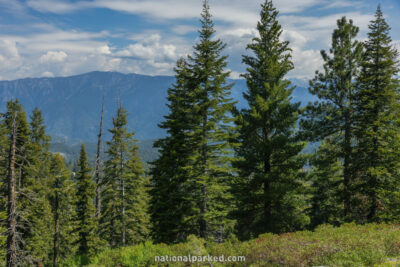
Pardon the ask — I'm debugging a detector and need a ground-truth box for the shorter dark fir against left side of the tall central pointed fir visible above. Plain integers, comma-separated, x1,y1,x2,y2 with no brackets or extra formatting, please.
150,58,195,243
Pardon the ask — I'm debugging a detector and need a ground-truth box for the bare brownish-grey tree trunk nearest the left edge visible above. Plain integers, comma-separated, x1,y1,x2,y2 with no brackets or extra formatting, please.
7,115,18,267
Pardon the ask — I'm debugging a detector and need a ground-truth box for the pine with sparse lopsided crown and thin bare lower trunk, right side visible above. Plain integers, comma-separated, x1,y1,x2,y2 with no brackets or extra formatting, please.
302,17,362,220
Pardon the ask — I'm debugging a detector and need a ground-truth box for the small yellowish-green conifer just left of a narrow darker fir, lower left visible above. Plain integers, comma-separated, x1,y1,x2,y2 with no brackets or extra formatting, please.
48,154,76,266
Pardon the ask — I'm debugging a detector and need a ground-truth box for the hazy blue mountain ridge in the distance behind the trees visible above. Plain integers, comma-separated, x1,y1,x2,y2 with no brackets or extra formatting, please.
0,71,313,143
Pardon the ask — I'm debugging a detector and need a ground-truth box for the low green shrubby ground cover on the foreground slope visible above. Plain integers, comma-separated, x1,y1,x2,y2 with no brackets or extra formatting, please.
64,224,400,267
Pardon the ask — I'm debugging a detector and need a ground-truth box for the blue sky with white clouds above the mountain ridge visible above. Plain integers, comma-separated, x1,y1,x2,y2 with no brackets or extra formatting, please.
0,0,400,80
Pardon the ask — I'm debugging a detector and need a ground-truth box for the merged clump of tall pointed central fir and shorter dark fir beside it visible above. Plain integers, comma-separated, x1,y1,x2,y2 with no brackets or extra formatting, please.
151,1,234,242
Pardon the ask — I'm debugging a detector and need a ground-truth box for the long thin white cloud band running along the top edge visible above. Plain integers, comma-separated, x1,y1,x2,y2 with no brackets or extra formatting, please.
23,0,332,25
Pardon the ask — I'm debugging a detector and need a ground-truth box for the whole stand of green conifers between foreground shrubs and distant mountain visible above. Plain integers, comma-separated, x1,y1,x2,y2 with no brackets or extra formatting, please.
0,0,400,267
